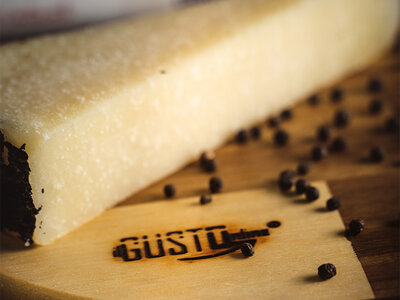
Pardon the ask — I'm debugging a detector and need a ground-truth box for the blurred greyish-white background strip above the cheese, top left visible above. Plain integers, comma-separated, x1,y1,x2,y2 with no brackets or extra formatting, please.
0,0,209,42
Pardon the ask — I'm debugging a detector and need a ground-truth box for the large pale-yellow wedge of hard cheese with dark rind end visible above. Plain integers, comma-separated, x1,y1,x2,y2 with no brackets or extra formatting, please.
0,0,399,245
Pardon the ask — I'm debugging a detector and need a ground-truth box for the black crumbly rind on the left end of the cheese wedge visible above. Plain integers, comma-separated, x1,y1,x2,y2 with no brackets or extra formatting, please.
0,132,39,245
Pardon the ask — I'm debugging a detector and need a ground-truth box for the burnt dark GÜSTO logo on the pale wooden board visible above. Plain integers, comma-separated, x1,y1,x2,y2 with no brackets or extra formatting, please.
113,221,281,262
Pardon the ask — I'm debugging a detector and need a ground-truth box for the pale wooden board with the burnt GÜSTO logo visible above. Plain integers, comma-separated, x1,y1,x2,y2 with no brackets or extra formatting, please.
0,182,374,299
